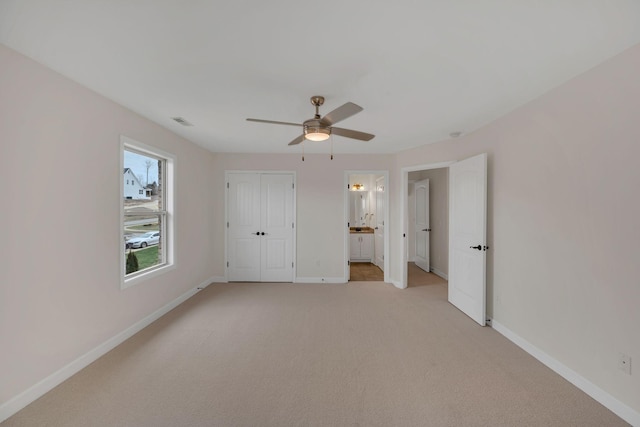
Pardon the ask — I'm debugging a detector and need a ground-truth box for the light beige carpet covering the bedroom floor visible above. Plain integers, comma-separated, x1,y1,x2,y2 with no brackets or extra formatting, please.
2,282,626,427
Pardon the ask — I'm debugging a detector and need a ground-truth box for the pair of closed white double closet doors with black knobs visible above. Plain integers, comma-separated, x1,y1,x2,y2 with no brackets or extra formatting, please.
227,173,294,282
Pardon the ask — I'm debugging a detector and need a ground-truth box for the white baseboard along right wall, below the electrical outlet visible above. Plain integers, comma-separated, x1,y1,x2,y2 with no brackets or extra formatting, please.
491,319,640,426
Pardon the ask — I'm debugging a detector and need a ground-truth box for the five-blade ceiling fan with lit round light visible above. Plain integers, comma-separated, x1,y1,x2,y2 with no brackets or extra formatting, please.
247,96,375,145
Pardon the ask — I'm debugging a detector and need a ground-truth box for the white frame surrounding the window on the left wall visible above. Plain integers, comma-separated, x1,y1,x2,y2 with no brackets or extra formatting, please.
118,135,176,290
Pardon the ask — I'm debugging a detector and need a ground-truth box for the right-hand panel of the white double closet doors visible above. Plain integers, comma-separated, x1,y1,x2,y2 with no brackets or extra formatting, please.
260,174,294,282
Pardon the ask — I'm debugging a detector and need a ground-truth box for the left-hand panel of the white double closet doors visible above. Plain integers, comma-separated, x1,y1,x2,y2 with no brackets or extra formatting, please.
227,173,261,282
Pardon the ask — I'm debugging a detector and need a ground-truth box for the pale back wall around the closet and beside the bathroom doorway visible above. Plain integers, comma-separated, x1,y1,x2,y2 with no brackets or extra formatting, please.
210,153,391,280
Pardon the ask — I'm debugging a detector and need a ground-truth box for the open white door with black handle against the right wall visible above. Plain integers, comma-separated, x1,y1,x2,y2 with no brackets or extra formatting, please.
449,153,488,326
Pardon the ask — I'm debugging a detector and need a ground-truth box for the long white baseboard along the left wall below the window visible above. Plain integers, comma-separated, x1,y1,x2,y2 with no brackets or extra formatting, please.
0,277,217,423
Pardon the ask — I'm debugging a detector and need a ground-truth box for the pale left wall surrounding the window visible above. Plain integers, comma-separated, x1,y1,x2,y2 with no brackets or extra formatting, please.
0,45,223,407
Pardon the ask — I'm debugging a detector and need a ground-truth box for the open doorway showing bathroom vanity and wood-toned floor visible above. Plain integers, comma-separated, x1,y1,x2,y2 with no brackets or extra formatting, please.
344,171,389,282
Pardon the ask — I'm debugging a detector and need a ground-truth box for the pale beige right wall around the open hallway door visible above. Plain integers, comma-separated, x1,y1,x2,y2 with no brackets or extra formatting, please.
391,46,640,413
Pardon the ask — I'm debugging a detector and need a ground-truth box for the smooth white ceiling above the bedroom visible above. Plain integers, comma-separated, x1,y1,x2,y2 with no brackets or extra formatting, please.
0,0,640,153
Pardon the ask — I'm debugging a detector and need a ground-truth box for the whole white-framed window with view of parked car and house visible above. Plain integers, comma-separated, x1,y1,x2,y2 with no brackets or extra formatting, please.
120,137,175,288
